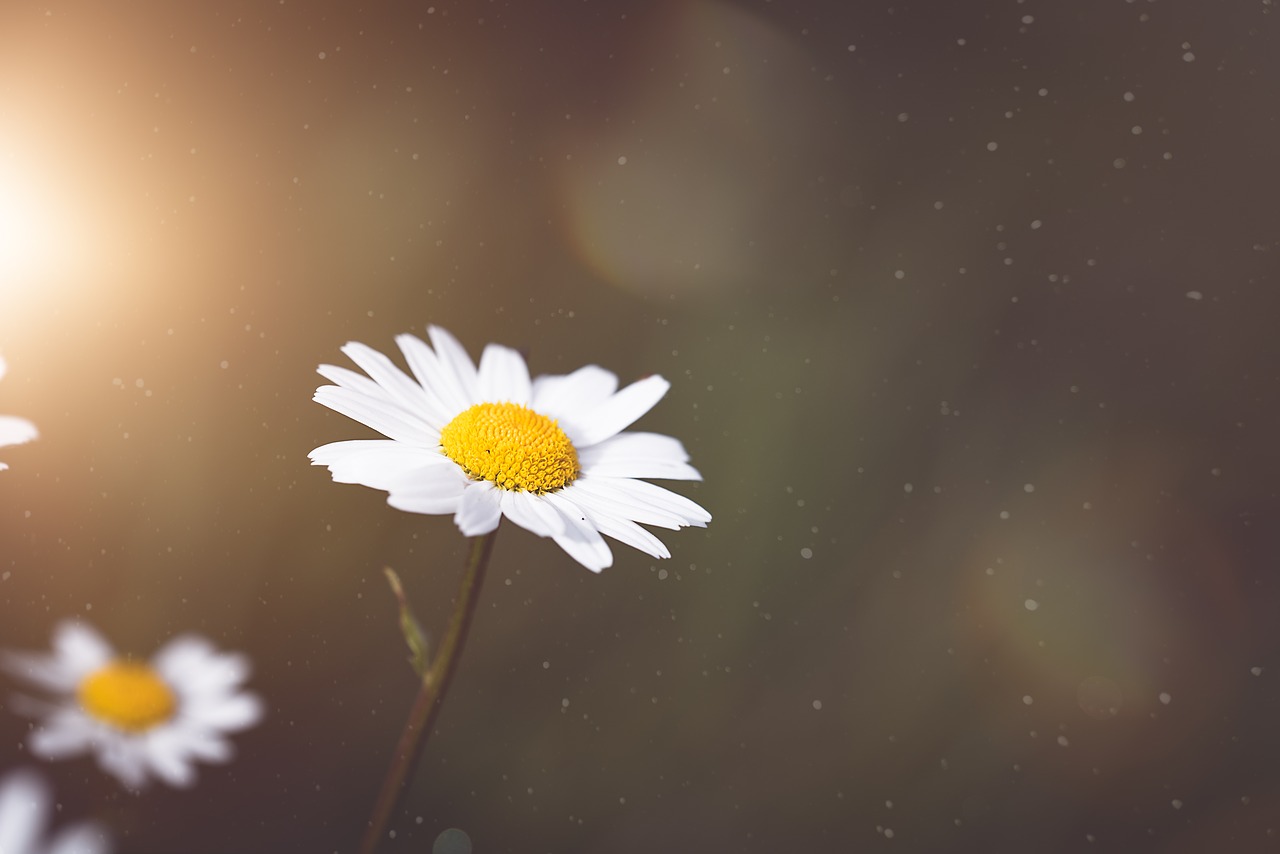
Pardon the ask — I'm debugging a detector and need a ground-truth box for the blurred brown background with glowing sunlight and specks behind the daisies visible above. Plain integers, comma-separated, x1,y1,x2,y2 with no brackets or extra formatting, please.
0,0,1280,853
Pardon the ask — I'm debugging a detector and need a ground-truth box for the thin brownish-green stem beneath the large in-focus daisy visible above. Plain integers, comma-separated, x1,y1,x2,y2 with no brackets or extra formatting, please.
360,529,498,854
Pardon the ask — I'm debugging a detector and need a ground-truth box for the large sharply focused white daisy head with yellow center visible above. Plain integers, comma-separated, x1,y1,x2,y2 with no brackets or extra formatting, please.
310,326,710,572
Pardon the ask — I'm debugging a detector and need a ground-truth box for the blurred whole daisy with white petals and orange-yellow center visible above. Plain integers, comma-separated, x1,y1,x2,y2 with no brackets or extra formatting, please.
0,622,262,791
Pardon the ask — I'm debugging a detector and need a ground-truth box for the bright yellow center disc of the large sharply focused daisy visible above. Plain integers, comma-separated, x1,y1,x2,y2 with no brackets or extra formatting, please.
440,403,579,493
